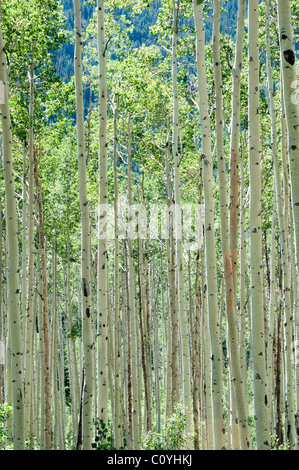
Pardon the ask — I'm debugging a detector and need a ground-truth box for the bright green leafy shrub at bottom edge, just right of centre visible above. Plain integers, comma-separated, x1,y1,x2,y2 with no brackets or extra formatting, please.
143,403,188,450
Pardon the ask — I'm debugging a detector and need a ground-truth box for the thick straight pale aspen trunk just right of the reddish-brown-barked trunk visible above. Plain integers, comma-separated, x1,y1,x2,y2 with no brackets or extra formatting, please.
248,0,270,450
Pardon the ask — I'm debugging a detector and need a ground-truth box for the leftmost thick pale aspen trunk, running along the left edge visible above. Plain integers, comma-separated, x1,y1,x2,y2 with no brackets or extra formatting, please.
0,6,25,450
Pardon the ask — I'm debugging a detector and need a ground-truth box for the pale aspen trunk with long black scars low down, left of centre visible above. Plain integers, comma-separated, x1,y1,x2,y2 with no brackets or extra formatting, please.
74,0,94,450
